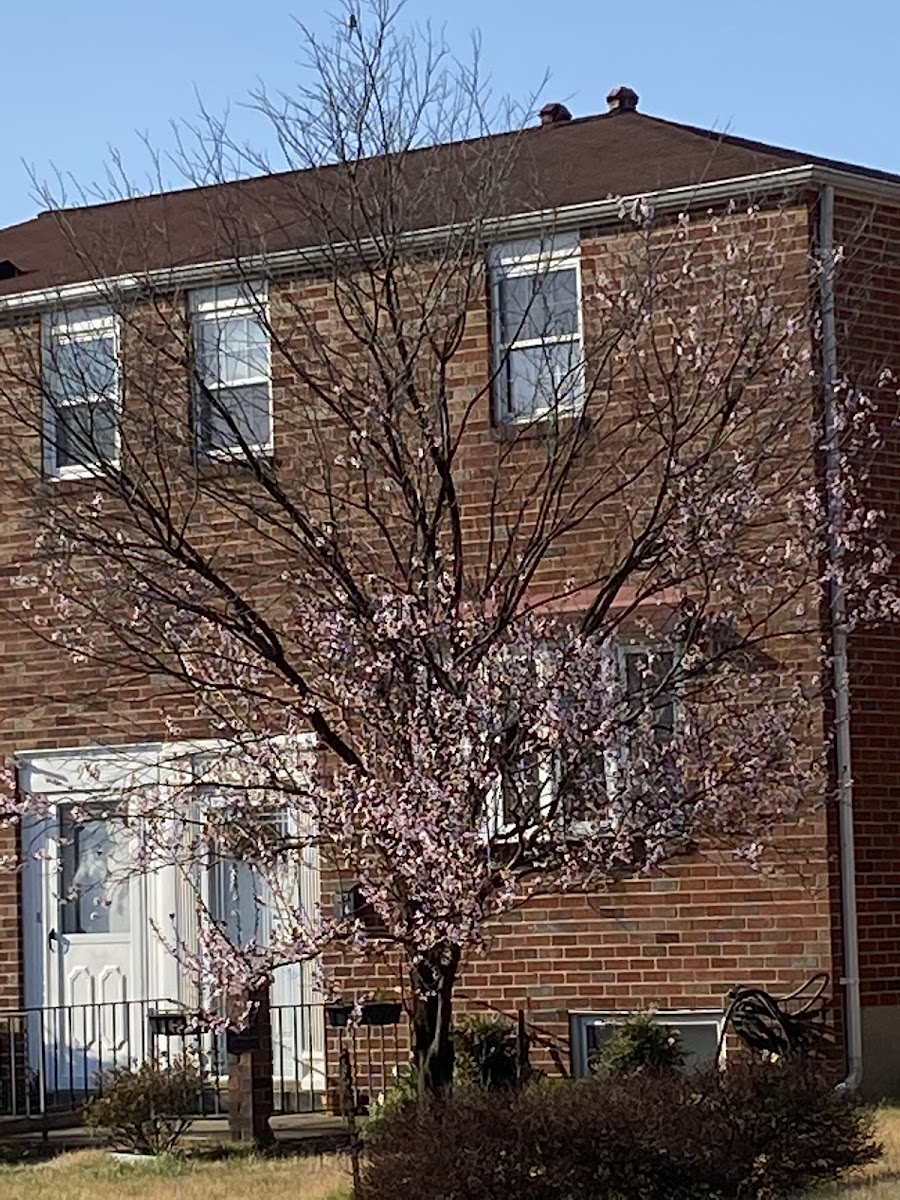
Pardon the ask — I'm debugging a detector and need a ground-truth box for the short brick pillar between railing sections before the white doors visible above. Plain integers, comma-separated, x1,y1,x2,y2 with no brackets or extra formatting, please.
227,988,275,1146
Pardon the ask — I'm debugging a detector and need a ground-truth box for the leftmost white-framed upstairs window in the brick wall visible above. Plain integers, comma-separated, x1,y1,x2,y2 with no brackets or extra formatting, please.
43,308,121,479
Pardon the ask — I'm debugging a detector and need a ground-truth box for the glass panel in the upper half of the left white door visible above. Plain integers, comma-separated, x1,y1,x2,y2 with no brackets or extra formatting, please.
60,808,131,934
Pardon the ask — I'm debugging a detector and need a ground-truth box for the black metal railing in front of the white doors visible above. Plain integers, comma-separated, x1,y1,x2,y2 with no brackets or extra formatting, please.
0,1000,406,1117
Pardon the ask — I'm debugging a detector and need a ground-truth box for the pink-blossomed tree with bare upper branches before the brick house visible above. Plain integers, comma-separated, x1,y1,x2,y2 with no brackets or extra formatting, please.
0,0,896,1092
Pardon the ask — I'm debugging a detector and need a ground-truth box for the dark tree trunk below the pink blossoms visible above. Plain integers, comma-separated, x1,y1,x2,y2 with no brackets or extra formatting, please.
409,948,460,1103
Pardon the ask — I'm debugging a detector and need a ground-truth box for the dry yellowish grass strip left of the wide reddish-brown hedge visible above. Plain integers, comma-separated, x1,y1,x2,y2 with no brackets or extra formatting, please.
0,1150,349,1200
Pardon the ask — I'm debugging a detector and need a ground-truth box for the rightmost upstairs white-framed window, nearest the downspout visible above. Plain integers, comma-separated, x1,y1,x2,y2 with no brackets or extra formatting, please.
491,234,584,424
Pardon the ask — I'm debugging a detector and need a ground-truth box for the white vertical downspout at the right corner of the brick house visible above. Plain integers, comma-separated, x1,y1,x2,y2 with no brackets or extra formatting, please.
818,184,863,1091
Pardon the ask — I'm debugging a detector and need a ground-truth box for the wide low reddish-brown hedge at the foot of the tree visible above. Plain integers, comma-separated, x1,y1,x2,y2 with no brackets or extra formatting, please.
359,1062,880,1200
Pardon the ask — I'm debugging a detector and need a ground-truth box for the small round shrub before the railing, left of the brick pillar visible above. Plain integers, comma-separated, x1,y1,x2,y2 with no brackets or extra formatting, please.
84,1055,203,1154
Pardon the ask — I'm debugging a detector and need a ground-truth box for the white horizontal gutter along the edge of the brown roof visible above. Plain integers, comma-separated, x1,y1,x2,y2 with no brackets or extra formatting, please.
0,163,900,318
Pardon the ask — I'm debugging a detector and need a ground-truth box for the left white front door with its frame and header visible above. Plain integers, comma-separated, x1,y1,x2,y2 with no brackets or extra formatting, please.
19,748,160,1094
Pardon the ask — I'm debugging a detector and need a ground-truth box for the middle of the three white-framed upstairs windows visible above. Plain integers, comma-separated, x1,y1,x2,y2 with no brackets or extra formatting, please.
191,283,272,456
